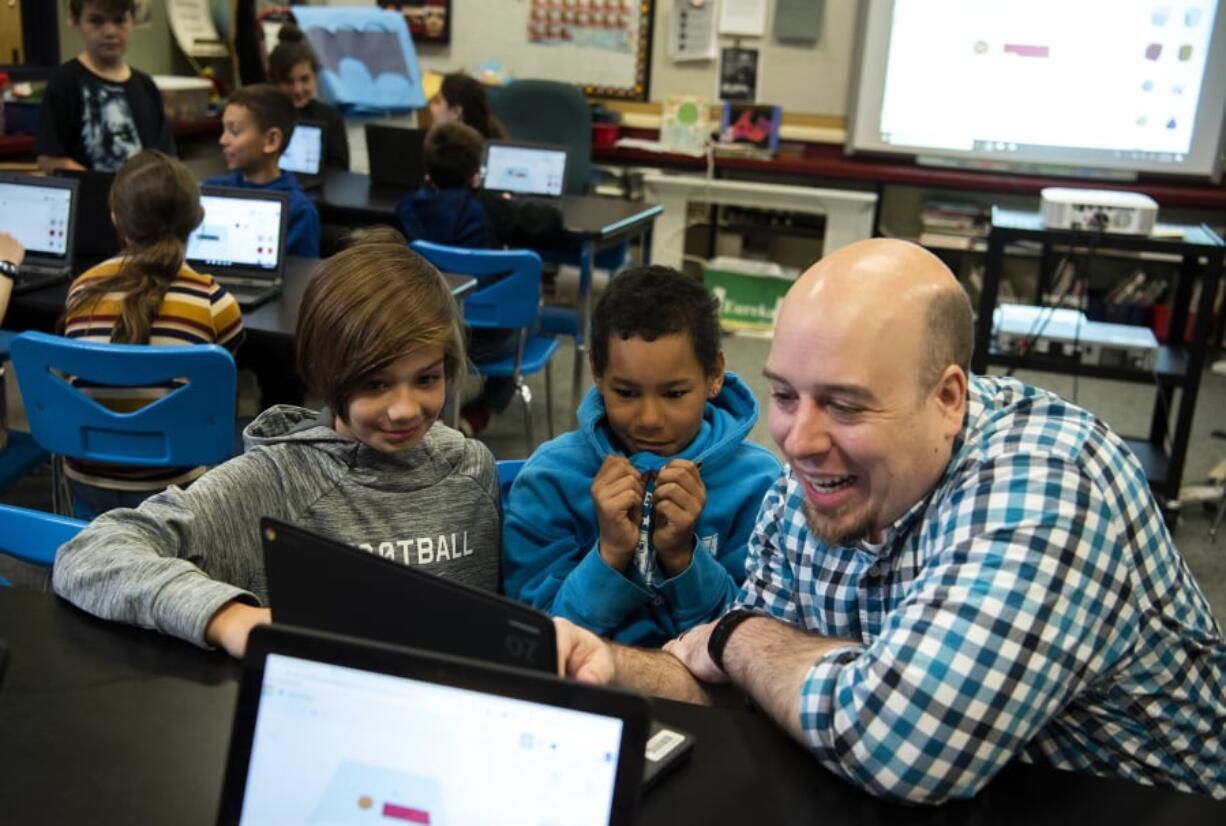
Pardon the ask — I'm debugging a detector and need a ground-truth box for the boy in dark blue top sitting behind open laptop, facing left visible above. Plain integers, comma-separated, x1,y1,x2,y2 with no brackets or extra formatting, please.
205,83,320,259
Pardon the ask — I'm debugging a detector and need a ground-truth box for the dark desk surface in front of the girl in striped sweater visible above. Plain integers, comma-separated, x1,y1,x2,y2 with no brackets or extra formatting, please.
7,256,477,338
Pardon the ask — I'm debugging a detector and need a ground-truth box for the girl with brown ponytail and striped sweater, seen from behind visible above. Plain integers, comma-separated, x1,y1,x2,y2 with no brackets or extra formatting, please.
63,150,243,518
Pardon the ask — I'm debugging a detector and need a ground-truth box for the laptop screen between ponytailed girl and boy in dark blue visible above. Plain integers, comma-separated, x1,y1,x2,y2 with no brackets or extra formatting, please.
188,194,286,271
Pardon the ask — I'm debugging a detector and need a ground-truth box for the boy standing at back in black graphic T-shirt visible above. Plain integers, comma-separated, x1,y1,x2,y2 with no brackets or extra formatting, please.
34,0,174,174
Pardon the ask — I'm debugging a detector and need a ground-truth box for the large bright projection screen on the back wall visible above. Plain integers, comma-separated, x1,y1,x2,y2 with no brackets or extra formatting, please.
850,0,1226,175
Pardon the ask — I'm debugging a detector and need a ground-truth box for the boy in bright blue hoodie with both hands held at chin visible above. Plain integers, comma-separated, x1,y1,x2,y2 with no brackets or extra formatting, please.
503,267,782,646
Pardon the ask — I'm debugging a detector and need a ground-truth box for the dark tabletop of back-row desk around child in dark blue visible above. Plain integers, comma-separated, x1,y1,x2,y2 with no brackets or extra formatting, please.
308,169,660,240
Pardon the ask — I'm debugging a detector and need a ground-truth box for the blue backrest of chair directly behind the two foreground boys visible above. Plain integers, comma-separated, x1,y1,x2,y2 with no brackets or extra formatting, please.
409,241,541,328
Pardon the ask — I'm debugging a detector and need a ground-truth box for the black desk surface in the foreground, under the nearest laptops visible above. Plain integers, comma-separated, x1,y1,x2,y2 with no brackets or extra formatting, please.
0,588,1226,826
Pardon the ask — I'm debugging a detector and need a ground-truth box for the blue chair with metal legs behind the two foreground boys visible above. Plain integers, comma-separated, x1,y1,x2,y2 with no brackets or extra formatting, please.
409,241,558,446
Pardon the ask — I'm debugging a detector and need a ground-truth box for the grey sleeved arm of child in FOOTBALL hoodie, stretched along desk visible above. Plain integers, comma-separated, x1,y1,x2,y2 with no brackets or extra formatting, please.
53,450,304,646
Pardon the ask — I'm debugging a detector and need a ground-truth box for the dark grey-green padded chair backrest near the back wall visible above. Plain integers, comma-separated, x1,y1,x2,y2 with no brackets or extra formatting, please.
488,80,592,195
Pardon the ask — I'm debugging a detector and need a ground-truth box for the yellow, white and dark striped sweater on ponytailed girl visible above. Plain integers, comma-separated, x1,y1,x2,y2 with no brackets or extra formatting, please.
64,257,244,490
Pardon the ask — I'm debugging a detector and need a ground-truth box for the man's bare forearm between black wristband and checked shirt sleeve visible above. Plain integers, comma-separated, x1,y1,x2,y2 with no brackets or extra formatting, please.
723,616,855,743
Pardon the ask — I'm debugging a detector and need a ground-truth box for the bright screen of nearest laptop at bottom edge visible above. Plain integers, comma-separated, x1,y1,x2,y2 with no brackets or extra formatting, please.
240,653,623,825
